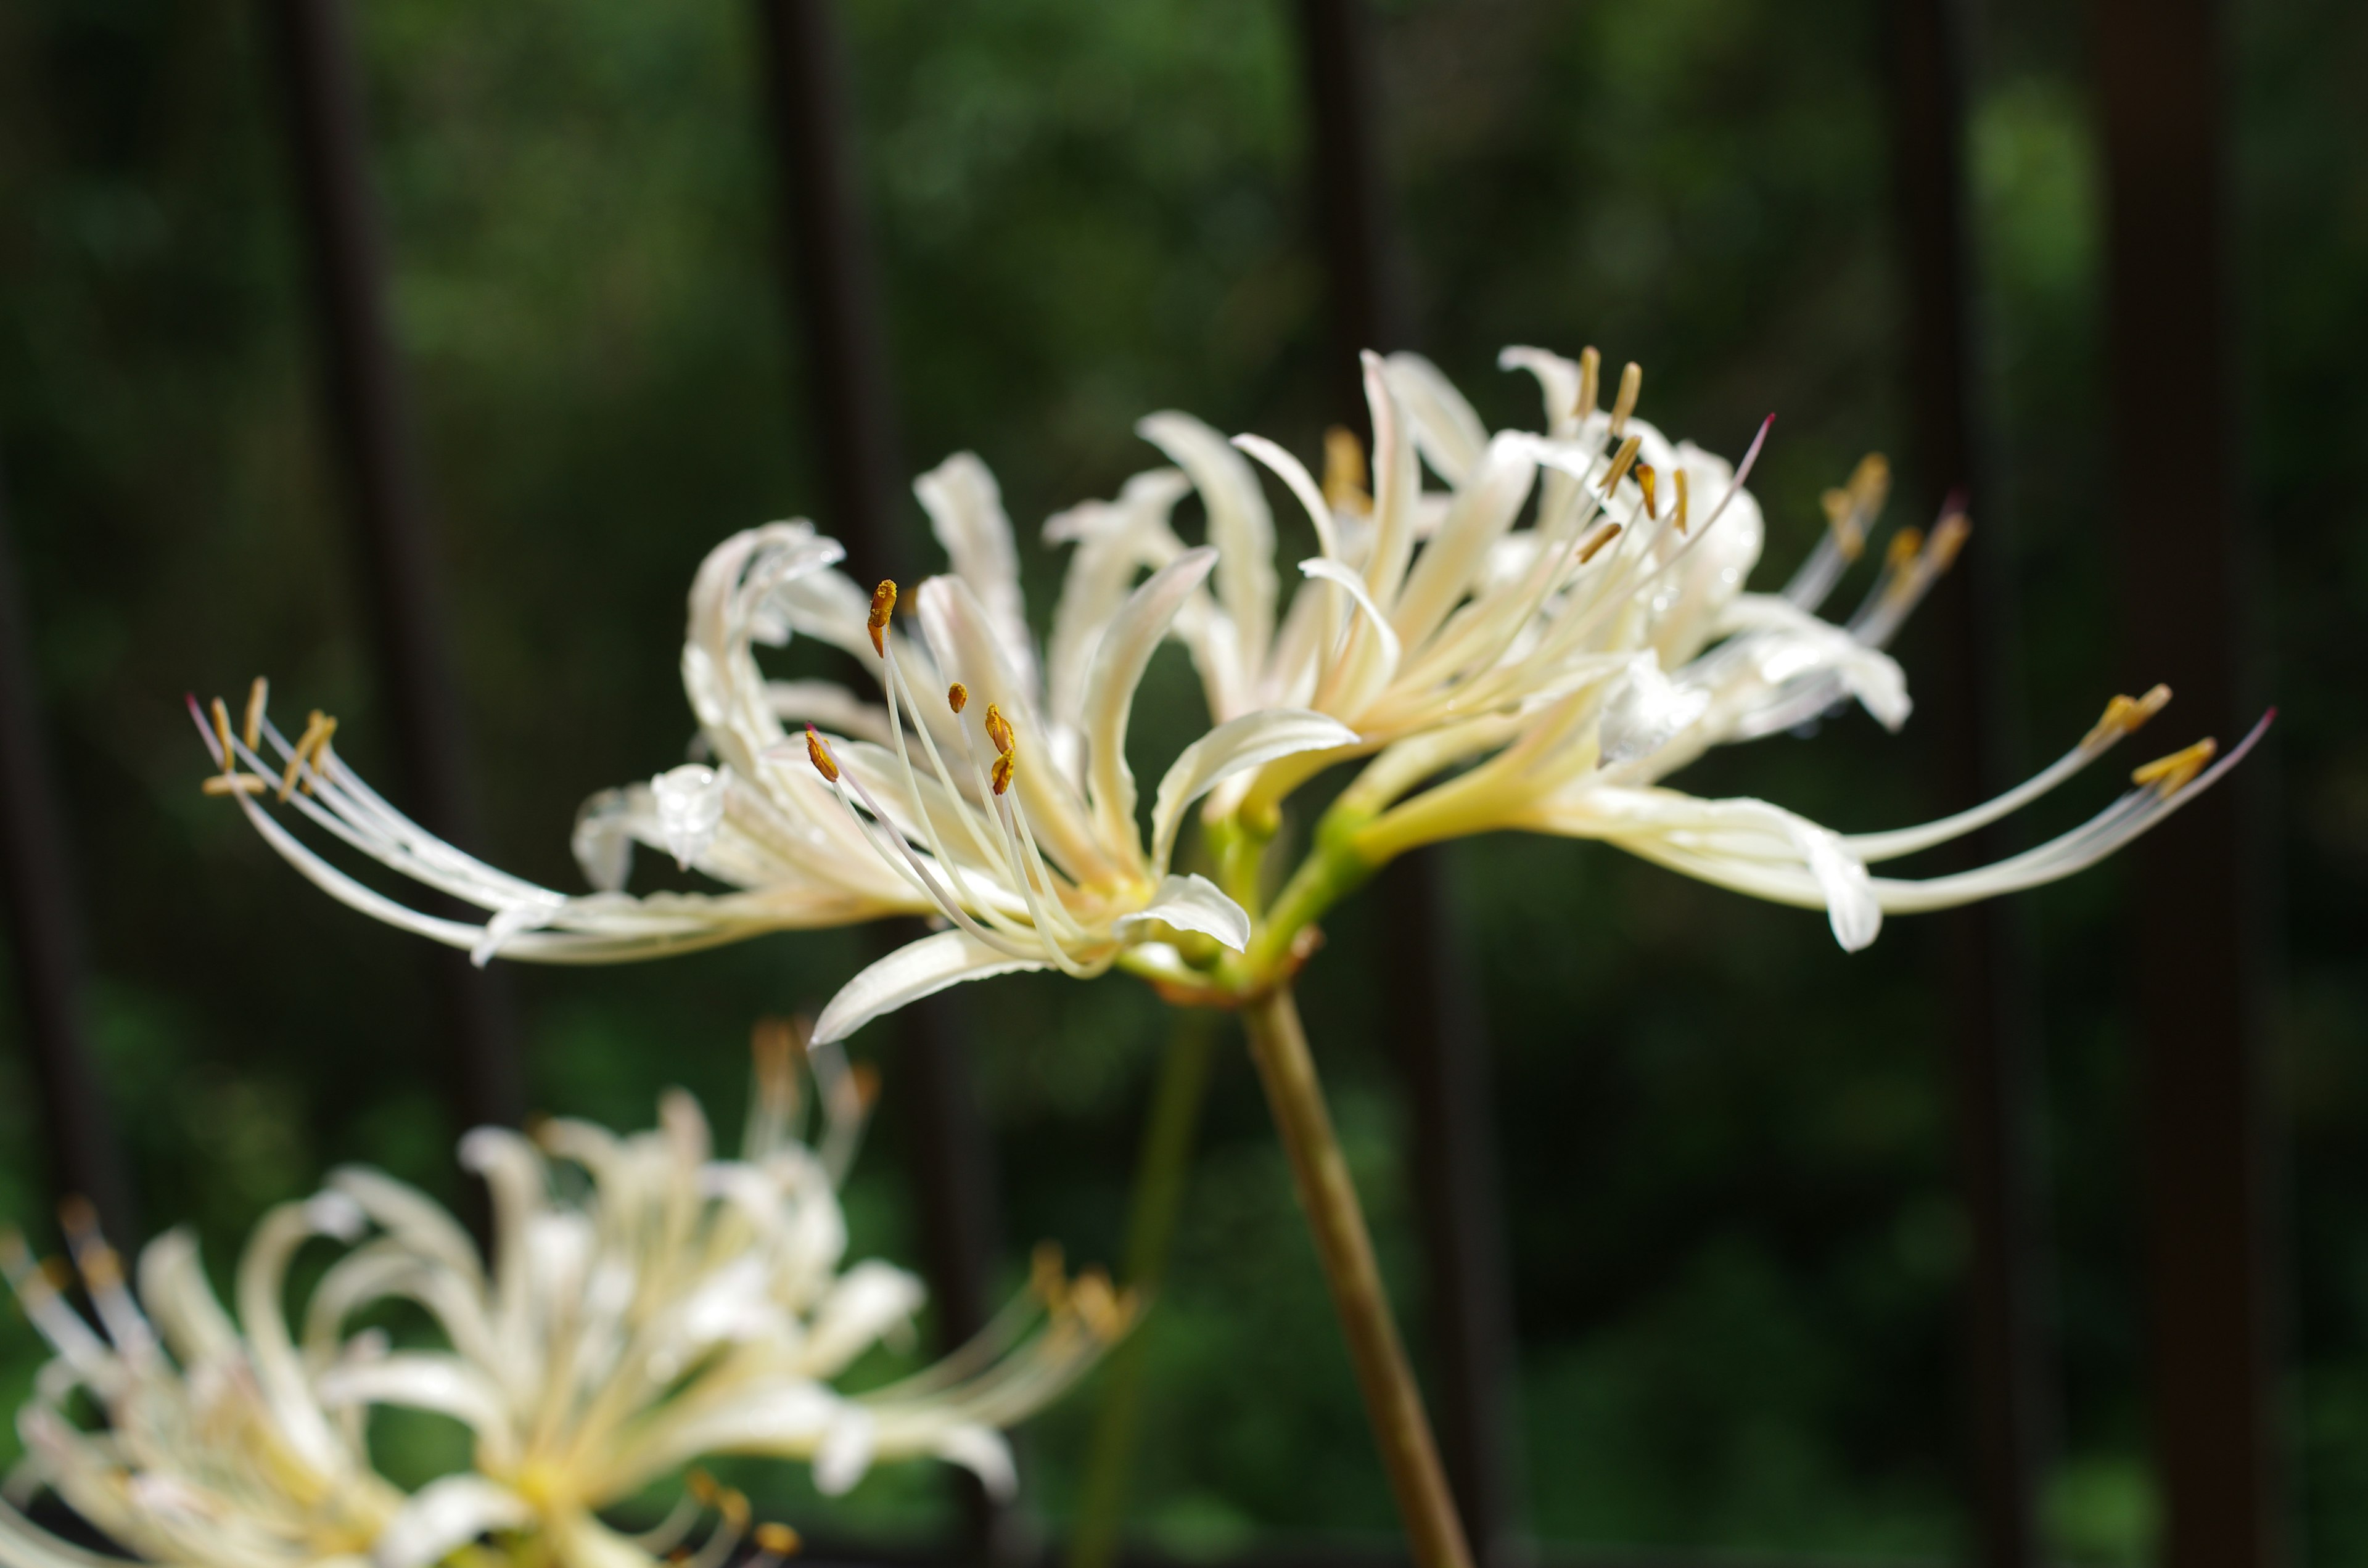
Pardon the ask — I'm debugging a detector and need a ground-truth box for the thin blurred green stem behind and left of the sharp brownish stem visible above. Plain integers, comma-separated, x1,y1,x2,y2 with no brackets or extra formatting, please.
1068,1009,1220,1568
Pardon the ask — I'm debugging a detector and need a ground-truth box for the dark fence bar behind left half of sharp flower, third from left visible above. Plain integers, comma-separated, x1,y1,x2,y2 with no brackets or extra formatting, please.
758,0,1001,1561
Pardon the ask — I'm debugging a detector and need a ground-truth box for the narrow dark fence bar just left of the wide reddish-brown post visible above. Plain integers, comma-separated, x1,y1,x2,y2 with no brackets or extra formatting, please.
1889,0,2053,1568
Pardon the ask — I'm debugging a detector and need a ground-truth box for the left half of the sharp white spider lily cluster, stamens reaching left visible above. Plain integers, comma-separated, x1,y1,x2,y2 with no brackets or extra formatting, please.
192,455,1357,1040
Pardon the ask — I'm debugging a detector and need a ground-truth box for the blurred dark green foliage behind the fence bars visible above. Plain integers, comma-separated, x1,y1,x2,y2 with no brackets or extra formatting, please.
0,0,2368,1563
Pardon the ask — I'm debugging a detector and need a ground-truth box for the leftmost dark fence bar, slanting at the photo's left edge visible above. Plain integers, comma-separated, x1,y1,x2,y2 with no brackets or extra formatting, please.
0,462,140,1246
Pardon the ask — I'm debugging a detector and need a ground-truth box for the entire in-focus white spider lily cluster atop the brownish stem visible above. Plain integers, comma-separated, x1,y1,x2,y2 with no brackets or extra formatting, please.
192,348,2266,1040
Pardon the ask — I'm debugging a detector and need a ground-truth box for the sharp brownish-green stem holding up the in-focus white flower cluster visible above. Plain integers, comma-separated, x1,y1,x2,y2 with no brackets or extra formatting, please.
1241,985,1473,1568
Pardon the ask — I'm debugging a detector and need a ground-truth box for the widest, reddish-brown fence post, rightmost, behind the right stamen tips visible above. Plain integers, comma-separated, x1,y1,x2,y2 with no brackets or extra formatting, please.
2095,0,2283,1568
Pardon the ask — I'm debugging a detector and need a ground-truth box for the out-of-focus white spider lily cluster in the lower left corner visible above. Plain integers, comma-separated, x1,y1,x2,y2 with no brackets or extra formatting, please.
0,1025,1132,1568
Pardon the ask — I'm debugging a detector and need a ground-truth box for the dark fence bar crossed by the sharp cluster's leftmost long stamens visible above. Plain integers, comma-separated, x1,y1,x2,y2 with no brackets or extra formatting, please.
268,0,525,1123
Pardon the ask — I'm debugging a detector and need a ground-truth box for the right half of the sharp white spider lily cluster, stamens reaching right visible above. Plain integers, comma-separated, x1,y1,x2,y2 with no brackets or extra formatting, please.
1098,348,2266,971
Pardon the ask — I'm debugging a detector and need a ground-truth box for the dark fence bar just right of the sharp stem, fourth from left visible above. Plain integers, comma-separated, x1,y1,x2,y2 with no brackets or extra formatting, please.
1300,0,1513,1568
